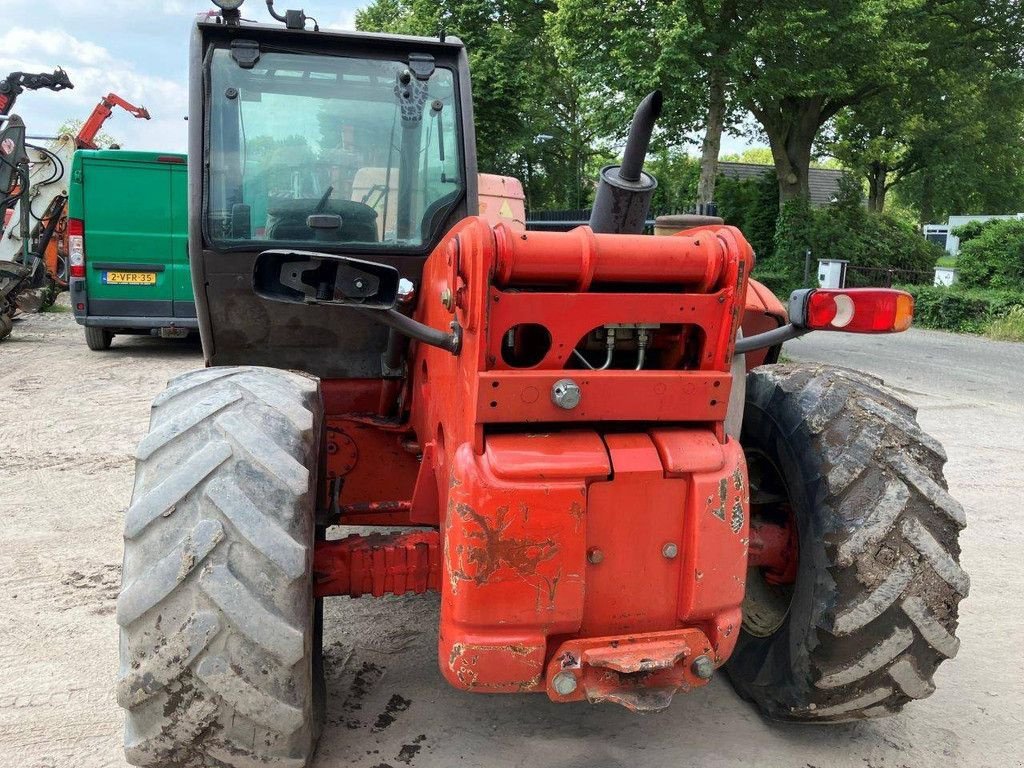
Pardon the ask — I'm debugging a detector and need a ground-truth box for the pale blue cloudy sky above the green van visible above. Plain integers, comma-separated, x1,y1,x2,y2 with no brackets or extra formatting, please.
0,0,365,152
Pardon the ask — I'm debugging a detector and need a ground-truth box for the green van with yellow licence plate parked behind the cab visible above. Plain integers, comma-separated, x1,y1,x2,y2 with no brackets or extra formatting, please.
68,150,199,350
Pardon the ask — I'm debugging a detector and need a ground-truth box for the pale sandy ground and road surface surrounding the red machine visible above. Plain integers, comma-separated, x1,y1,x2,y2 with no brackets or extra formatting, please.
0,301,1024,768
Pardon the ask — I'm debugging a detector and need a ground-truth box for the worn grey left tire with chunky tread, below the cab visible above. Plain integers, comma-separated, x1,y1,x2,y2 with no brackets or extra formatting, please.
117,367,325,768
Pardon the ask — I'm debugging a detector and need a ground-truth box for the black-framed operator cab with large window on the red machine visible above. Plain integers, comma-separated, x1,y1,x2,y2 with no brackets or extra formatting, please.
188,4,478,378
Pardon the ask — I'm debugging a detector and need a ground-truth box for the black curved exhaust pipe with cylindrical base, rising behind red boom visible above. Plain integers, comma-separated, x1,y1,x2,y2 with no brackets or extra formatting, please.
590,91,662,234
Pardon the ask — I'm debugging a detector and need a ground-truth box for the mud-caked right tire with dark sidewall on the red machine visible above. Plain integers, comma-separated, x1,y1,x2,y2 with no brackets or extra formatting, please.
727,365,970,722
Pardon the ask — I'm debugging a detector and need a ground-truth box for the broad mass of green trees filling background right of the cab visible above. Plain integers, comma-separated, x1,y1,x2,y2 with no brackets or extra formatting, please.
356,0,1024,221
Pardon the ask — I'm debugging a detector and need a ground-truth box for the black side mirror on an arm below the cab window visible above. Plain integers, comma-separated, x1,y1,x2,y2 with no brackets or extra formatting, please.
253,251,399,309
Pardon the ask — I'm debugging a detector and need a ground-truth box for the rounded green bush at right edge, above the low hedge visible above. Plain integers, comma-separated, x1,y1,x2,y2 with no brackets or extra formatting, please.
956,219,1024,291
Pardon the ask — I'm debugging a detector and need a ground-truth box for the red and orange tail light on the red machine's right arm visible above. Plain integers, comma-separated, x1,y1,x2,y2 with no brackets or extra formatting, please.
790,288,913,334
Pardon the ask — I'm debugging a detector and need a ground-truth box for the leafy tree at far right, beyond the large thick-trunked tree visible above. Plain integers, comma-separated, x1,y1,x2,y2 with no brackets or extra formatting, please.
826,0,1024,211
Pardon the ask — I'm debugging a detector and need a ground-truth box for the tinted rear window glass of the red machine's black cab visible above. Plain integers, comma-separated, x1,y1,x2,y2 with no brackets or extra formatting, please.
205,49,465,251
